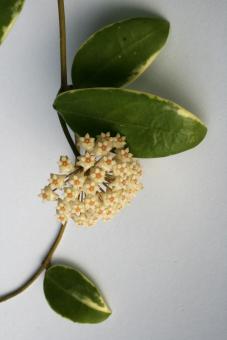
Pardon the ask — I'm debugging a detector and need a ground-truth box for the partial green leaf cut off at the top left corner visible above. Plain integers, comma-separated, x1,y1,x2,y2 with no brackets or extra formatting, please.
0,0,24,44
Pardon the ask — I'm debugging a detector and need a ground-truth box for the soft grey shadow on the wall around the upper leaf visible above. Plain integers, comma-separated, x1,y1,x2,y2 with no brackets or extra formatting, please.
66,3,204,119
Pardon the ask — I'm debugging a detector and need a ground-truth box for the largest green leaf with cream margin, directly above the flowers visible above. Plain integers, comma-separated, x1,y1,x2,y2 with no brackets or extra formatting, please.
54,88,207,157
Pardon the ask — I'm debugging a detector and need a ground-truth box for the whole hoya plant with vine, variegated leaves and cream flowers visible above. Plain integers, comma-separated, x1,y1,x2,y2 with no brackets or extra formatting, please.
0,0,207,323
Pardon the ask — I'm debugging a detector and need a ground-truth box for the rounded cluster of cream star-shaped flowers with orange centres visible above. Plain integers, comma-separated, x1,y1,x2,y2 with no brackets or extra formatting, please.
40,132,142,226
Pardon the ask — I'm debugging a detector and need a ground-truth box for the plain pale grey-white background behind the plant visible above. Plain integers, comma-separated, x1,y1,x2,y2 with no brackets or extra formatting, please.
0,0,227,340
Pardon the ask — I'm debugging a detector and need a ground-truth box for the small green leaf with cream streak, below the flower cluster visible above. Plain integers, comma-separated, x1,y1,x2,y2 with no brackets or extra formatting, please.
44,265,111,323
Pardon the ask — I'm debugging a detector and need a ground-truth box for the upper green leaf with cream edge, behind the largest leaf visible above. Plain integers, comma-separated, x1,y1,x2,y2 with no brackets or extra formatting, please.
72,18,169,88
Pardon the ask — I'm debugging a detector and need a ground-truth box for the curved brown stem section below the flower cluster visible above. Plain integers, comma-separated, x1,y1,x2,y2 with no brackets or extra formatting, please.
0,223,66,302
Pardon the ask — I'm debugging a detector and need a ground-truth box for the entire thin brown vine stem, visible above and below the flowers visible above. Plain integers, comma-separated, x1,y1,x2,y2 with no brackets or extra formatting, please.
0,0,71,302
